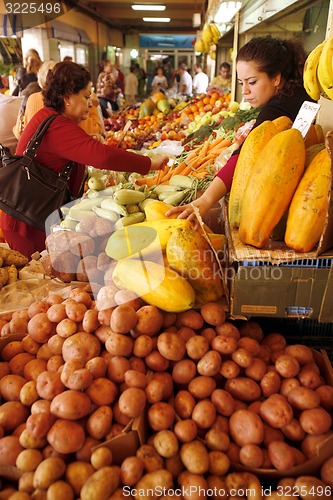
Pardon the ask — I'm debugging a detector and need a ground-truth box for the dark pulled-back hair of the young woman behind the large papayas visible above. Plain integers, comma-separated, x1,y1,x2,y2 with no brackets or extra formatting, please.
236,36,306,95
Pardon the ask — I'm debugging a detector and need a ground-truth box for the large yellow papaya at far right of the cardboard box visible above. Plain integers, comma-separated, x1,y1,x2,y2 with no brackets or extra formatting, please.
285,149,332,252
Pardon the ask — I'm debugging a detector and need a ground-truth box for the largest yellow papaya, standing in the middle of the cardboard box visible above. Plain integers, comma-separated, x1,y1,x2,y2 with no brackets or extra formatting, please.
239,129,305,248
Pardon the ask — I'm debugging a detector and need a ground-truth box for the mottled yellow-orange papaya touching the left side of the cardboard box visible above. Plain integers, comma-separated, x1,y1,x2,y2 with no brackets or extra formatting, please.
166,229,224,307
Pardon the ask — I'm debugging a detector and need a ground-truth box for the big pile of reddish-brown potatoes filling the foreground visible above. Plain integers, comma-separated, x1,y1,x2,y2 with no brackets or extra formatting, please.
0,285,333,500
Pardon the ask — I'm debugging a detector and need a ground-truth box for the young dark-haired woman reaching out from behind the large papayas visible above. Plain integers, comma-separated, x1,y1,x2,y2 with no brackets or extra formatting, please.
167,36,312,226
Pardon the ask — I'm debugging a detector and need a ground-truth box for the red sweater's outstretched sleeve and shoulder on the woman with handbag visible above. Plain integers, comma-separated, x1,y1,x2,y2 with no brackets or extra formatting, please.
16,108,151,174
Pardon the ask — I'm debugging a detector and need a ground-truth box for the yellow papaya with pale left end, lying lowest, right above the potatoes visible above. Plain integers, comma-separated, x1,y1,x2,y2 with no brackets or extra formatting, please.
112,259,195,313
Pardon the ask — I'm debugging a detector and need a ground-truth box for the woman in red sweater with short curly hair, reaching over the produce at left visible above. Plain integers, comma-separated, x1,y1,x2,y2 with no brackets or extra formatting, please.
0,62,168,258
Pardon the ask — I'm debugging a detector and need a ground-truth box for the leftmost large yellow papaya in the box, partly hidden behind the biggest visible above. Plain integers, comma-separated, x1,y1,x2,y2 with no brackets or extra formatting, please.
228,120,277,228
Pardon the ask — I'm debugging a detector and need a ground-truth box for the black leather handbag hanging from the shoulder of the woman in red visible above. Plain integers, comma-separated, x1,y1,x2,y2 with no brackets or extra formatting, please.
0,114,73,231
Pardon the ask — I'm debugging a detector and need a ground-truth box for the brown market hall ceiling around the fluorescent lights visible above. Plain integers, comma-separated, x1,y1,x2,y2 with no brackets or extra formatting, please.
66,0,208,33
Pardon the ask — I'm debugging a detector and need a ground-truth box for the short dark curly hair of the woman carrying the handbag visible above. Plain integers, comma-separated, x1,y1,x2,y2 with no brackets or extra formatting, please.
42,62,91,113
